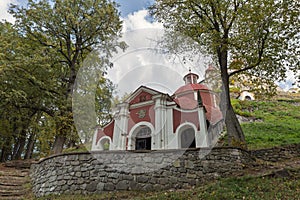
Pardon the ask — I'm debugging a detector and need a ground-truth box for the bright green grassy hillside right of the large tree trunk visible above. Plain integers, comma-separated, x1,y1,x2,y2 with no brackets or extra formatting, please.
232,99,300,149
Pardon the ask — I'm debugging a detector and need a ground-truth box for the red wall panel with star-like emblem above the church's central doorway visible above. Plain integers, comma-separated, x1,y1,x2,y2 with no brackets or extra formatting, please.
128,105,155,133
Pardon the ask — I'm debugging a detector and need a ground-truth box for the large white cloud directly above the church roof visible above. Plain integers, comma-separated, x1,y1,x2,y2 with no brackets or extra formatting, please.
108,10,203,96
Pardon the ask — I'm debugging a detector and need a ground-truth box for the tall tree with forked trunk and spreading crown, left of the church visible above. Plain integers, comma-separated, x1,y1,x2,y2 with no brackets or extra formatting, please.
10,0,125,153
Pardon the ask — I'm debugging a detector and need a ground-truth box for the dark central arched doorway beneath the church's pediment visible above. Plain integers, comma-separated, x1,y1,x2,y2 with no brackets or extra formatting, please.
135,126,151,150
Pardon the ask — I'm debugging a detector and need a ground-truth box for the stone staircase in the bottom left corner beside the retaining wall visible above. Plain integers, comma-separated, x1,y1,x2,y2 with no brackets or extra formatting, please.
0,162,31,200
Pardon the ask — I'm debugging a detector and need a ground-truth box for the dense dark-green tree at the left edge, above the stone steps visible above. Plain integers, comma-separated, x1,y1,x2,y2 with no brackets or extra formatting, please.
0,23,57,161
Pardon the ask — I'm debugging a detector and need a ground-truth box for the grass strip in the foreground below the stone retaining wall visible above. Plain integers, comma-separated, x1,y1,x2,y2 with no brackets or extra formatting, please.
29,170,300,200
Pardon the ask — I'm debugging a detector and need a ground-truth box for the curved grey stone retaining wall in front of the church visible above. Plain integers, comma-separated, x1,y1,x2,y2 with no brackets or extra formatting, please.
31,148,254,196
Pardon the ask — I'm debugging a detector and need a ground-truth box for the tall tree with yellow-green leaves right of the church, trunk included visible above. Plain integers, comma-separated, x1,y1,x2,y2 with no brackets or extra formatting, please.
150,0,300,145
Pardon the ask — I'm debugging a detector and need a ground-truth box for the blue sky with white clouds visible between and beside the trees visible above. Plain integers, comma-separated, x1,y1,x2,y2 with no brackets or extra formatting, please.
0,0,295,93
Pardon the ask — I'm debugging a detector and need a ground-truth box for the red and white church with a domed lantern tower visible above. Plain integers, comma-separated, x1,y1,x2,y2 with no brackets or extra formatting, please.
92,71,223,151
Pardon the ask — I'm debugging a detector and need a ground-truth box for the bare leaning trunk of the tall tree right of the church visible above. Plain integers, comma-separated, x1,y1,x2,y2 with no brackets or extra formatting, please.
218,45,246,147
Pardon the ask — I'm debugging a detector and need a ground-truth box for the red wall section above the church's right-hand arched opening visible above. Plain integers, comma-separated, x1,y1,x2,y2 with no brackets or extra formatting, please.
173,109,200,133
